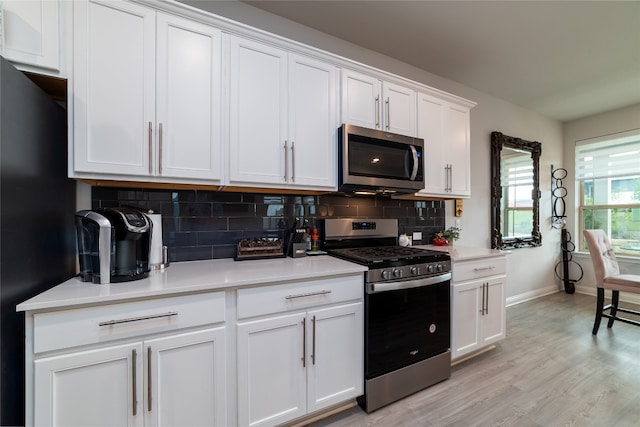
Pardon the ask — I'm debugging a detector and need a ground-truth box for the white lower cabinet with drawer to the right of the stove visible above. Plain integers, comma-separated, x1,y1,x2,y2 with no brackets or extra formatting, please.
451,256,506,360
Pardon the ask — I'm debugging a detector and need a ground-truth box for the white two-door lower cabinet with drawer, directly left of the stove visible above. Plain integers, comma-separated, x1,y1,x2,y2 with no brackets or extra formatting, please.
237,275,363,426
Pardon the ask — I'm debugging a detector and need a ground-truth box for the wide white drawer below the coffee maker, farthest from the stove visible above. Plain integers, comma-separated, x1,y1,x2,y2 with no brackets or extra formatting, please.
33,292,225,353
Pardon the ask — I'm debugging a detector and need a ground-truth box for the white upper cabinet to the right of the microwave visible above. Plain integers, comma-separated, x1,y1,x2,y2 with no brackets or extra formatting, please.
418,93,473,197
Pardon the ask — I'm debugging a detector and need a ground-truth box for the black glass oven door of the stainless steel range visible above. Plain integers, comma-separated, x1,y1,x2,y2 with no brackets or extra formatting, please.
365,273,451,379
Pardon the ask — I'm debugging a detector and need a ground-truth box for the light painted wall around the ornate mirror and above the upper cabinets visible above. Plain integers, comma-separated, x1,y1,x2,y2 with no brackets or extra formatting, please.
184,1,562,302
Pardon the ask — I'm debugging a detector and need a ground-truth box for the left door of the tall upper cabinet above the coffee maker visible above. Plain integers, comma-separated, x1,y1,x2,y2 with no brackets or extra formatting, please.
72,0,156,175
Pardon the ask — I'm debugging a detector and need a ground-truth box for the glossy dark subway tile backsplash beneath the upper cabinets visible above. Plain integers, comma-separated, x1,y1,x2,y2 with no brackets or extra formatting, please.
91,187,445,262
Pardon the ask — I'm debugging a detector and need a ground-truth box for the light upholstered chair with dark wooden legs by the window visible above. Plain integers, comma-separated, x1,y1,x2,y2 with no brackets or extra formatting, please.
584,230,640,335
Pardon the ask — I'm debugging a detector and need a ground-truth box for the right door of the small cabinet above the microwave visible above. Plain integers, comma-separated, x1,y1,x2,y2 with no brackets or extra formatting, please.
382,82,416,136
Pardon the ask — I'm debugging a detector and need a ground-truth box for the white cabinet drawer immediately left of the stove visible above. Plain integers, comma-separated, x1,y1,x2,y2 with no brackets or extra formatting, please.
238,274,364,319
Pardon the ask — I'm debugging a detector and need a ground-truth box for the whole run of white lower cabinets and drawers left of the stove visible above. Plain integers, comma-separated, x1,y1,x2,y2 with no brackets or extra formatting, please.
26,272,364,427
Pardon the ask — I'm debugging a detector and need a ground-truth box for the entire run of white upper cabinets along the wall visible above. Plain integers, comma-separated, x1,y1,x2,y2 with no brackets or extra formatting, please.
67,0,473,191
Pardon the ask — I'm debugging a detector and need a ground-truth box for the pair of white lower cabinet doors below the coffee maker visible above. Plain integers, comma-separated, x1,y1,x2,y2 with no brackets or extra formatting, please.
35,328,226,426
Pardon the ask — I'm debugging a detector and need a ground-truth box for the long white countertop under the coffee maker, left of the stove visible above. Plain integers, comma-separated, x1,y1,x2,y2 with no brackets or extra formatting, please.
17,255,367,311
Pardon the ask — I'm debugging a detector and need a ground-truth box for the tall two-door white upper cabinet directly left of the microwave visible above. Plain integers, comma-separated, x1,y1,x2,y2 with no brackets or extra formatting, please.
229,36,338,190
